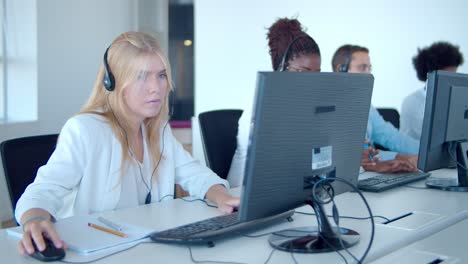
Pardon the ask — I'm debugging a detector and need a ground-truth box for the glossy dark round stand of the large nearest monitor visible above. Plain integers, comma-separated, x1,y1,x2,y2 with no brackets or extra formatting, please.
268,201,359,253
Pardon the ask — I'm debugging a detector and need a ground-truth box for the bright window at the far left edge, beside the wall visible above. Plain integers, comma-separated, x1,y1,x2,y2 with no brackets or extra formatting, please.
0,0,38,123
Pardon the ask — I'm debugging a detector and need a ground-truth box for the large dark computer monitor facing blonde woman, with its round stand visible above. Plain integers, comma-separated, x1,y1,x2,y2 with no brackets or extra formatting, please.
239,72,374,252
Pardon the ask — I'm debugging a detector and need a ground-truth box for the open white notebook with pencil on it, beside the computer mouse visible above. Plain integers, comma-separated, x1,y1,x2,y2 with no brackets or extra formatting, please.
7,216,155,254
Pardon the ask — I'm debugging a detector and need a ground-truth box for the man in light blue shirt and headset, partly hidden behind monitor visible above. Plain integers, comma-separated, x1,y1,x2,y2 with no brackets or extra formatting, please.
332,45,419,173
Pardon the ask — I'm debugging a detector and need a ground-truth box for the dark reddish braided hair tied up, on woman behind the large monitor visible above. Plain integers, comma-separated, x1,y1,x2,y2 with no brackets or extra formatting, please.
267,18,320,71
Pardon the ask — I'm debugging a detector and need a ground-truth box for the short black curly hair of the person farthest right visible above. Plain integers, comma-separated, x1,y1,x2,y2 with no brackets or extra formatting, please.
413,41,463,82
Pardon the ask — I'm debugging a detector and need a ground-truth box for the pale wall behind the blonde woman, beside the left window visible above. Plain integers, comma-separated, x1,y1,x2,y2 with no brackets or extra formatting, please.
0,0,136,224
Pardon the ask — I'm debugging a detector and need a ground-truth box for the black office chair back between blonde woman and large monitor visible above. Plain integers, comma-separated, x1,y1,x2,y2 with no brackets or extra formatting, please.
198,109,242,179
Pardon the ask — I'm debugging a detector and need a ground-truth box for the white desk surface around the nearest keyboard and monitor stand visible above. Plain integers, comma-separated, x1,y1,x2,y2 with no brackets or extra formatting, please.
0,170,468,263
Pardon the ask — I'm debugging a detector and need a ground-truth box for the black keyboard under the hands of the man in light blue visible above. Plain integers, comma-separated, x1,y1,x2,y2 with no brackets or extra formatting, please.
358,171,431,192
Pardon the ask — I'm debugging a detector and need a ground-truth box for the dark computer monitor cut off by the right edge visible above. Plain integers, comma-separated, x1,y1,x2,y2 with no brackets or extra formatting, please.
418,71,468,192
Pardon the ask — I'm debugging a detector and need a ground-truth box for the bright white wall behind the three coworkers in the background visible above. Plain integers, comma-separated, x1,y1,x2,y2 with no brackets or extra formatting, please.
193,0,468,161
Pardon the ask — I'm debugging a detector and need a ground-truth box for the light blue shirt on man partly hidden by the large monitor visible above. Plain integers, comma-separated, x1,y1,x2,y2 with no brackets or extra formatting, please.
366,106,419,160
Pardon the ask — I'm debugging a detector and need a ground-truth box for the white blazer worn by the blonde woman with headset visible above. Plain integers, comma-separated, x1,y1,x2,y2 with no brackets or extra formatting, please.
15,114,229,222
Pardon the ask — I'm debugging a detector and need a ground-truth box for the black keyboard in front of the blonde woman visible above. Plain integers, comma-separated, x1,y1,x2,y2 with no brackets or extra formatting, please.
150,211,294,244
